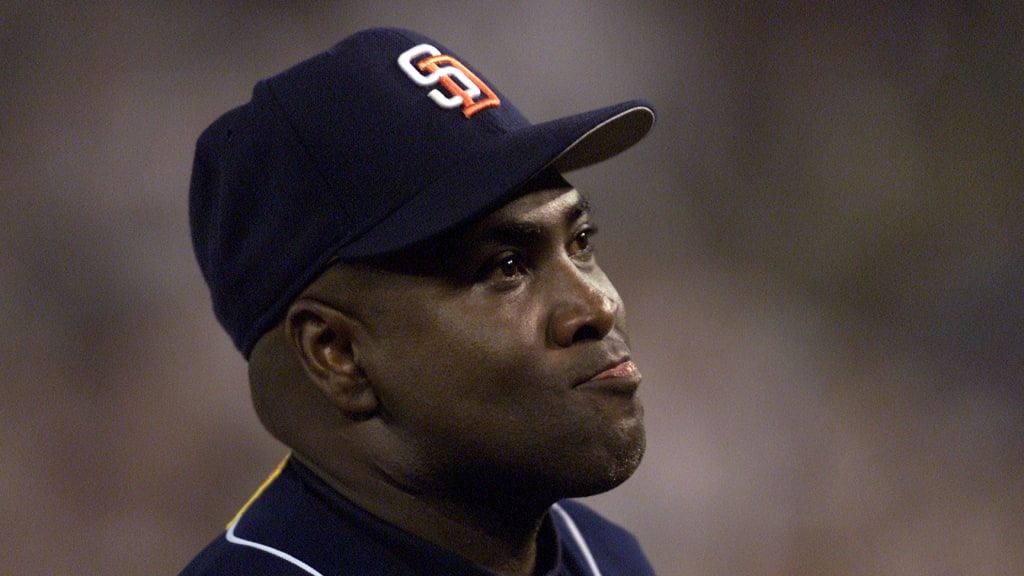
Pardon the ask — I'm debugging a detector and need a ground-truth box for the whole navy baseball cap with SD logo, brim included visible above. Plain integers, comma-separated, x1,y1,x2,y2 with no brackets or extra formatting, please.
189,29,654,358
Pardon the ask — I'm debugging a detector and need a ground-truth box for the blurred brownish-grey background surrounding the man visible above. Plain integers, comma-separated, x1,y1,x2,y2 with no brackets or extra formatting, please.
0,0,1024,576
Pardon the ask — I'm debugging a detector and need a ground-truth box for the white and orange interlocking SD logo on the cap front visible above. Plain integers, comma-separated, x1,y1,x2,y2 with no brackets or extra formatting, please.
398,44,502,118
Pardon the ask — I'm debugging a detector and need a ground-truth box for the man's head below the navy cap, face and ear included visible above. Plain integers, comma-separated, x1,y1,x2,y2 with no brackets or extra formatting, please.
252,168,644,500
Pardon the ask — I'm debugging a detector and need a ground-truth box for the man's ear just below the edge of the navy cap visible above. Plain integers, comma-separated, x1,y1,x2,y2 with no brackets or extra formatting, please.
285,297,378,420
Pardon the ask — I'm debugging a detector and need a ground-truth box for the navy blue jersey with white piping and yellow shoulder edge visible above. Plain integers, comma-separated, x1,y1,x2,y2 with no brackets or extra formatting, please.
181,458,654,576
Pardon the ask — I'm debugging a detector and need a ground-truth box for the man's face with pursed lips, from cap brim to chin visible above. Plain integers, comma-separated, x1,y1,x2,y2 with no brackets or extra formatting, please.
354,183,644,498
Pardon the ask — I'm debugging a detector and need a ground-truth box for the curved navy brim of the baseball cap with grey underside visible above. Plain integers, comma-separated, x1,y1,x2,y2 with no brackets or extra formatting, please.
335,100,654,259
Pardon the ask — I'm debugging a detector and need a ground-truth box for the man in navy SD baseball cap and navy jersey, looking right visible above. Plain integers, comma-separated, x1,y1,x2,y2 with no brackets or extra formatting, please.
184,29,654,576
